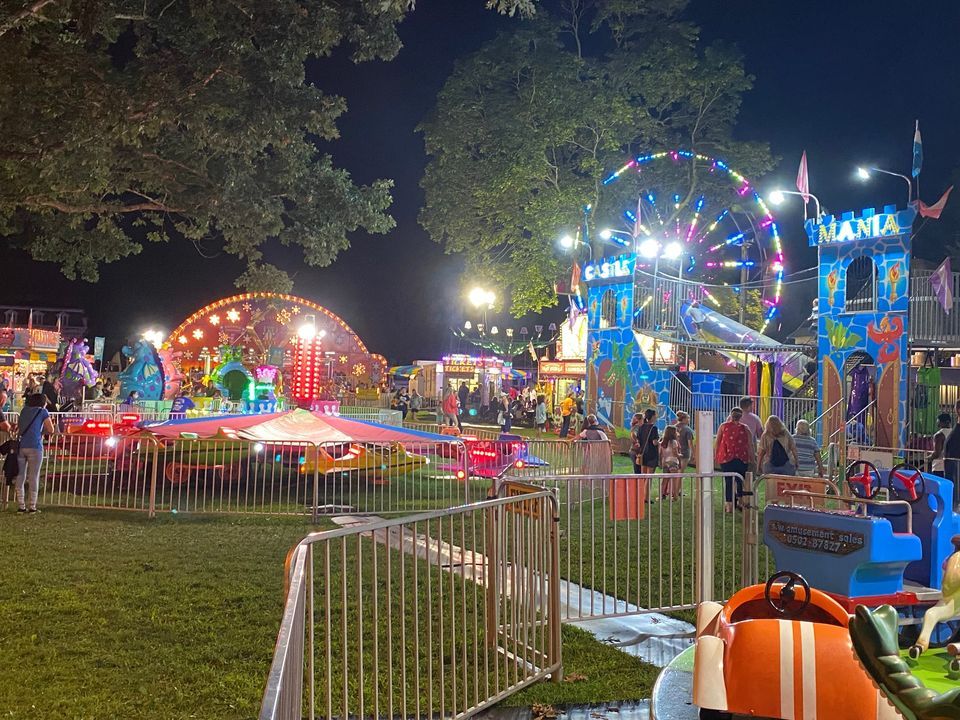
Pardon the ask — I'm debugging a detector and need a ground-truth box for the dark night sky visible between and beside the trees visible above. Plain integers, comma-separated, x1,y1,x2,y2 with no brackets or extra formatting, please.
0,0,960,362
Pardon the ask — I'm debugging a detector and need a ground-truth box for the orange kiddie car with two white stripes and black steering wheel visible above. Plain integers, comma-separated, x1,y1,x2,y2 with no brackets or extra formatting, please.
693,571,900,720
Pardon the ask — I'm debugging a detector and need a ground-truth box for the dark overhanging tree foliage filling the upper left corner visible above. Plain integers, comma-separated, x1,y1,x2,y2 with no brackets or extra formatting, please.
0,0,532,289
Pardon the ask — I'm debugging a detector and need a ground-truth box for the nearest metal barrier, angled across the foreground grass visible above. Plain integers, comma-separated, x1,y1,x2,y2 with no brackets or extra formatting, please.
259,486,561,720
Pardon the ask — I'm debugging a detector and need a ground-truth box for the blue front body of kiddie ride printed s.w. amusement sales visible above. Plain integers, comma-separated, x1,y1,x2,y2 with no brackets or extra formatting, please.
763,505,922,597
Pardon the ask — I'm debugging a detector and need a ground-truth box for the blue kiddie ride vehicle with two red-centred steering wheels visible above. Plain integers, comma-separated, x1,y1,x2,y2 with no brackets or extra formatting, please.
763,460,960,647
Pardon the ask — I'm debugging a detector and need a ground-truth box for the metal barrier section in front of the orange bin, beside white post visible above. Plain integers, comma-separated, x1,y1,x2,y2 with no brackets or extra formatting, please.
504,472,746,621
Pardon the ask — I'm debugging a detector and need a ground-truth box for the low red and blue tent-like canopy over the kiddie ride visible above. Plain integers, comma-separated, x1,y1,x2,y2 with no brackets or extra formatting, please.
146,410,455,443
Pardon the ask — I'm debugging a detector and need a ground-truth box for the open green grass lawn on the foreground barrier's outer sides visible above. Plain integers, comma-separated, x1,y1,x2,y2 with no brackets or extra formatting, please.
0,509,656,720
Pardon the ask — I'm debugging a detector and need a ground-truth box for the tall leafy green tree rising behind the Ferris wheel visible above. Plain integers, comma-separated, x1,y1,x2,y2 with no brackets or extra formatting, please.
421,0,772,316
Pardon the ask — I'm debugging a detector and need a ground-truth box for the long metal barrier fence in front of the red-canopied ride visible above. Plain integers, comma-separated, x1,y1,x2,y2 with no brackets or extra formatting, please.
2,433,491,519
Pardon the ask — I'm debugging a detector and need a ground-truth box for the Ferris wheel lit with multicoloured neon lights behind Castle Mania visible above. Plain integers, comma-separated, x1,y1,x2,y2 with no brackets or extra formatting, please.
603,150,784,332
